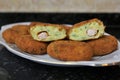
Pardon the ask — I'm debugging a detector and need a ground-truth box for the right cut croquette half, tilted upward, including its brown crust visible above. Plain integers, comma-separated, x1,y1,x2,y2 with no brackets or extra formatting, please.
68,18,105,41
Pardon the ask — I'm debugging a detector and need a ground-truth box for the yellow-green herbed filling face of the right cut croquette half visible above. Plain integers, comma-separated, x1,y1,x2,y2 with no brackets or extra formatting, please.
69,22,105,41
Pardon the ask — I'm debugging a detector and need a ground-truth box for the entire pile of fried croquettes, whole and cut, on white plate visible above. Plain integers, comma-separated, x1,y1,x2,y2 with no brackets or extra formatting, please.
2,18,118,61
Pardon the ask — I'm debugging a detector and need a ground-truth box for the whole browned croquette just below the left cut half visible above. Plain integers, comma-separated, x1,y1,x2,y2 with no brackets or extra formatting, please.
15,35,48,55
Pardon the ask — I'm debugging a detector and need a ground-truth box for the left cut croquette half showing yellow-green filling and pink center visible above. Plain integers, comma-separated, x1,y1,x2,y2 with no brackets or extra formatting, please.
30,23,67,42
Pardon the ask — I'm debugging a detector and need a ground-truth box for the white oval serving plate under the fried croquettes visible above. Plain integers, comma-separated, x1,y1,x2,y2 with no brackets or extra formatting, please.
0,22,120,67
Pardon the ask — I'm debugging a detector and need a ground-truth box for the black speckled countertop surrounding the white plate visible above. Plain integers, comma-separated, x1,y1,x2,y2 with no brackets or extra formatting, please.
0,13,120,80
